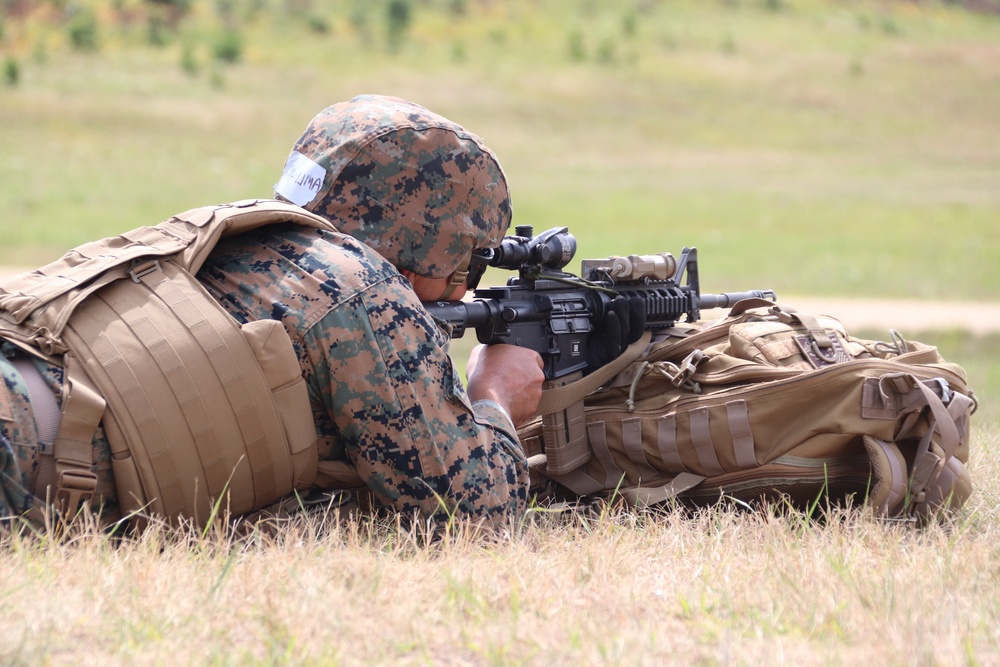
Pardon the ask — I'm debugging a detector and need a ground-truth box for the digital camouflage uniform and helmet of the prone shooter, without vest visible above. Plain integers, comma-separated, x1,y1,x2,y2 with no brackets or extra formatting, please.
0,96,528,520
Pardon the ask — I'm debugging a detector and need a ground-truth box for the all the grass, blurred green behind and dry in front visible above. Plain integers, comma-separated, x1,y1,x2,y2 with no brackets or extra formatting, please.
0,0,1000,665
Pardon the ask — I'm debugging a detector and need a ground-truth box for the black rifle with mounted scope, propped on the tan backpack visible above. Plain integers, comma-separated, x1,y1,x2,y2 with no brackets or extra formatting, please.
424,226,775,380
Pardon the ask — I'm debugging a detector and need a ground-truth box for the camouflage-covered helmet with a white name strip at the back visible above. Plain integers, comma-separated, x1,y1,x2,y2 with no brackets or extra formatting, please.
274,95,511,278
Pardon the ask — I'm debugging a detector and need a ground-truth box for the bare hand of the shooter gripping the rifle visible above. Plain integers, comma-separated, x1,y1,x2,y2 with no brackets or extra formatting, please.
466,345,545,426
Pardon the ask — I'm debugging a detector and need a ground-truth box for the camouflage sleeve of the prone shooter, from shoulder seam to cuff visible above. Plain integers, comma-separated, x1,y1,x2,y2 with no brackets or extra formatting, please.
302,277,527,517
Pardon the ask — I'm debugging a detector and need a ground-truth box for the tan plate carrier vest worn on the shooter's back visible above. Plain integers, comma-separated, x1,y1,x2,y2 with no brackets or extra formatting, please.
0,200,336,523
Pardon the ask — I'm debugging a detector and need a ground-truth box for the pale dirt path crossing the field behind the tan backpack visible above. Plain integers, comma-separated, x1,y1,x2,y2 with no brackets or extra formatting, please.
0,266,1000,336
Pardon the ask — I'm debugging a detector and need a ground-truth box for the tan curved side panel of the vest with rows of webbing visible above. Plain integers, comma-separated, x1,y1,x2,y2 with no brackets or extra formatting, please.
64,262,311,520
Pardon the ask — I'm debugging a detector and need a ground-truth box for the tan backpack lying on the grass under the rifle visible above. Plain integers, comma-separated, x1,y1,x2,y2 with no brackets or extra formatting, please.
519,300,975,517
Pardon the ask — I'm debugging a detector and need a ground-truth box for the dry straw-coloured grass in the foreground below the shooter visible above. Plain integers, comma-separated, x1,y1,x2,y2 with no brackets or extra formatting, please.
0,428,1000,665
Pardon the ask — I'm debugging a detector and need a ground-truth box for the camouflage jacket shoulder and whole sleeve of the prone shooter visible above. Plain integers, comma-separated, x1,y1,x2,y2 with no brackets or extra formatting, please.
199,231,528,520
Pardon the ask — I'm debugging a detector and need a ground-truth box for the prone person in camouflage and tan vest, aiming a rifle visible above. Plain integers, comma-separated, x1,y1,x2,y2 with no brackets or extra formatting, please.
0,95,544,524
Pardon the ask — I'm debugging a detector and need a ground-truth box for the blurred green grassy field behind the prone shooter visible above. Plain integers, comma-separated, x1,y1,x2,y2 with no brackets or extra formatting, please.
0,0,1000,418
